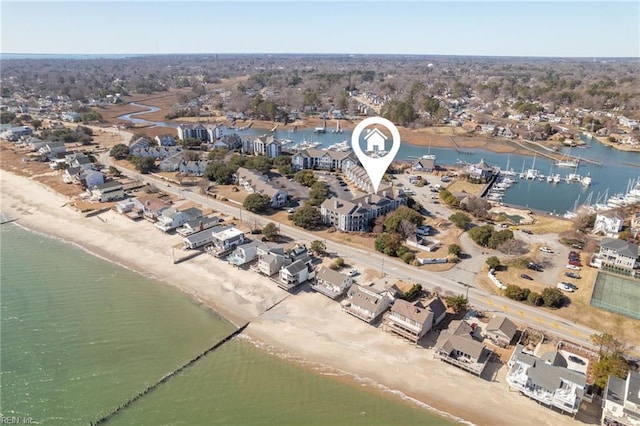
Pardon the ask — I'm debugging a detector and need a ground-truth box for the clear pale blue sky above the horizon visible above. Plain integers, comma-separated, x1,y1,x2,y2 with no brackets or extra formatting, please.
0,0,640,57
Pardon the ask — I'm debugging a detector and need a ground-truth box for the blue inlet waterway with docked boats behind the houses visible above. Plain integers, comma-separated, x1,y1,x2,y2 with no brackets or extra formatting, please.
118,104,640,215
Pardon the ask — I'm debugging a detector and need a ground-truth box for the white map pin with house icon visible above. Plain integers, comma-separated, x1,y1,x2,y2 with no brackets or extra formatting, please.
351,117,400,193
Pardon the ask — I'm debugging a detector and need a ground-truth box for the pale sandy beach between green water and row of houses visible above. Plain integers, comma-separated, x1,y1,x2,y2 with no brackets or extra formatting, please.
1,171,600,425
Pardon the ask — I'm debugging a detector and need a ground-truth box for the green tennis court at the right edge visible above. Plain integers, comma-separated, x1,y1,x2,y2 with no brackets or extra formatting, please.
591,272,640,319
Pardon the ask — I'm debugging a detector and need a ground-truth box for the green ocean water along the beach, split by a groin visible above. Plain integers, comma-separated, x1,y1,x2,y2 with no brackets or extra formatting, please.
0,224,453,425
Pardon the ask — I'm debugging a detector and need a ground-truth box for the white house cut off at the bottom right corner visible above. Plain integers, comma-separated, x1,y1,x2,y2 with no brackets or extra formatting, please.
601,370,640,426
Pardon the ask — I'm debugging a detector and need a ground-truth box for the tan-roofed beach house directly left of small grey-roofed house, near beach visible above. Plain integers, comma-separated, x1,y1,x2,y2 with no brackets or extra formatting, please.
434,321,493,377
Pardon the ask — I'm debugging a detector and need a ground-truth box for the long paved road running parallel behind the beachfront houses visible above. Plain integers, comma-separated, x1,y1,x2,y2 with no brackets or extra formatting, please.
101,148,640,354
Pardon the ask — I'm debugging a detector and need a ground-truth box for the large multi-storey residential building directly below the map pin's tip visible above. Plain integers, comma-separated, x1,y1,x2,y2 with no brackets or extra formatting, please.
320,190,407,231
